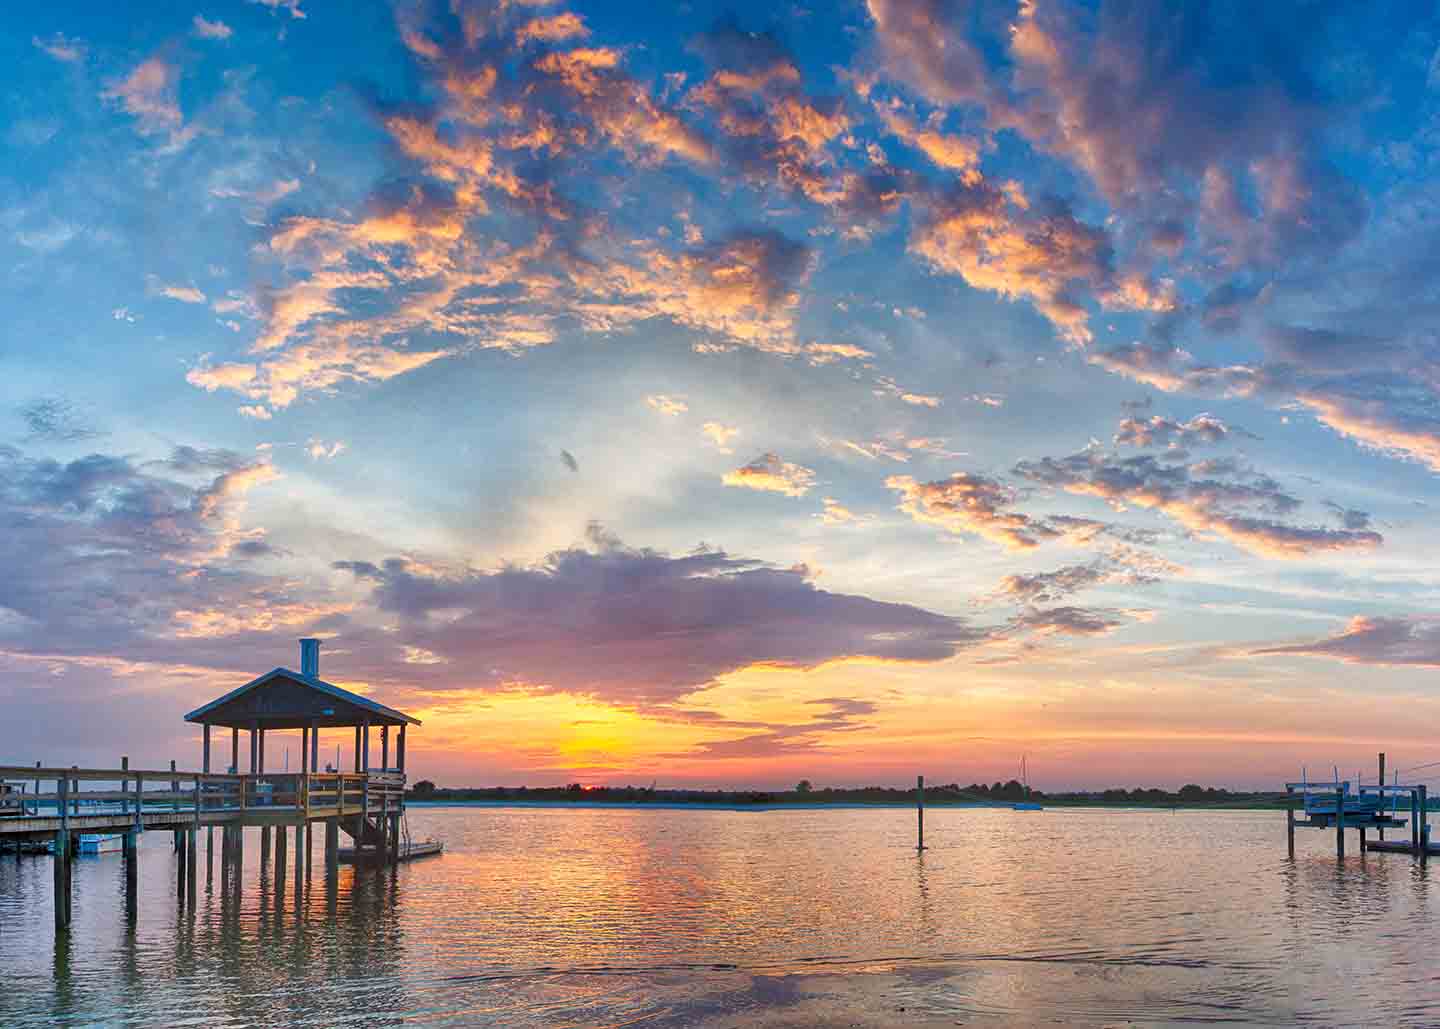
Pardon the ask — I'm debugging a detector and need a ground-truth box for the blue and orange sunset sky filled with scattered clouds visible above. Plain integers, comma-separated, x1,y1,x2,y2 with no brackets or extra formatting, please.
8,0,1440,789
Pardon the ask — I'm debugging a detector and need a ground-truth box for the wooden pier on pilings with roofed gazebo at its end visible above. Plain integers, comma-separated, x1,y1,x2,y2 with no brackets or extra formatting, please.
0,639,439,931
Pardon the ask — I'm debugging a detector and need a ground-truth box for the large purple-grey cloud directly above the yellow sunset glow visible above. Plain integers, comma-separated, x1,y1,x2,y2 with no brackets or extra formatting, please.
337,531,979,704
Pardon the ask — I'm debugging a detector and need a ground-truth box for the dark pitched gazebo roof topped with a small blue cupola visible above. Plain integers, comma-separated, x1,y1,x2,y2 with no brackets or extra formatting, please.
184,639,420,728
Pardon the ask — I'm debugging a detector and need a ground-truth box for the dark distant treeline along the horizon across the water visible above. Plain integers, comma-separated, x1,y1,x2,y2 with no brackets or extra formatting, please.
409,779,1284,807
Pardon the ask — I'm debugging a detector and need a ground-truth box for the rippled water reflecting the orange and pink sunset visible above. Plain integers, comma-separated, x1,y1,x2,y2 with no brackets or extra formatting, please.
0,807,1440,1029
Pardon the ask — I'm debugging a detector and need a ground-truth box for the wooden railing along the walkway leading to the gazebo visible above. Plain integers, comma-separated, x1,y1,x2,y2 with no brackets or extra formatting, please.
0,766,405,832
